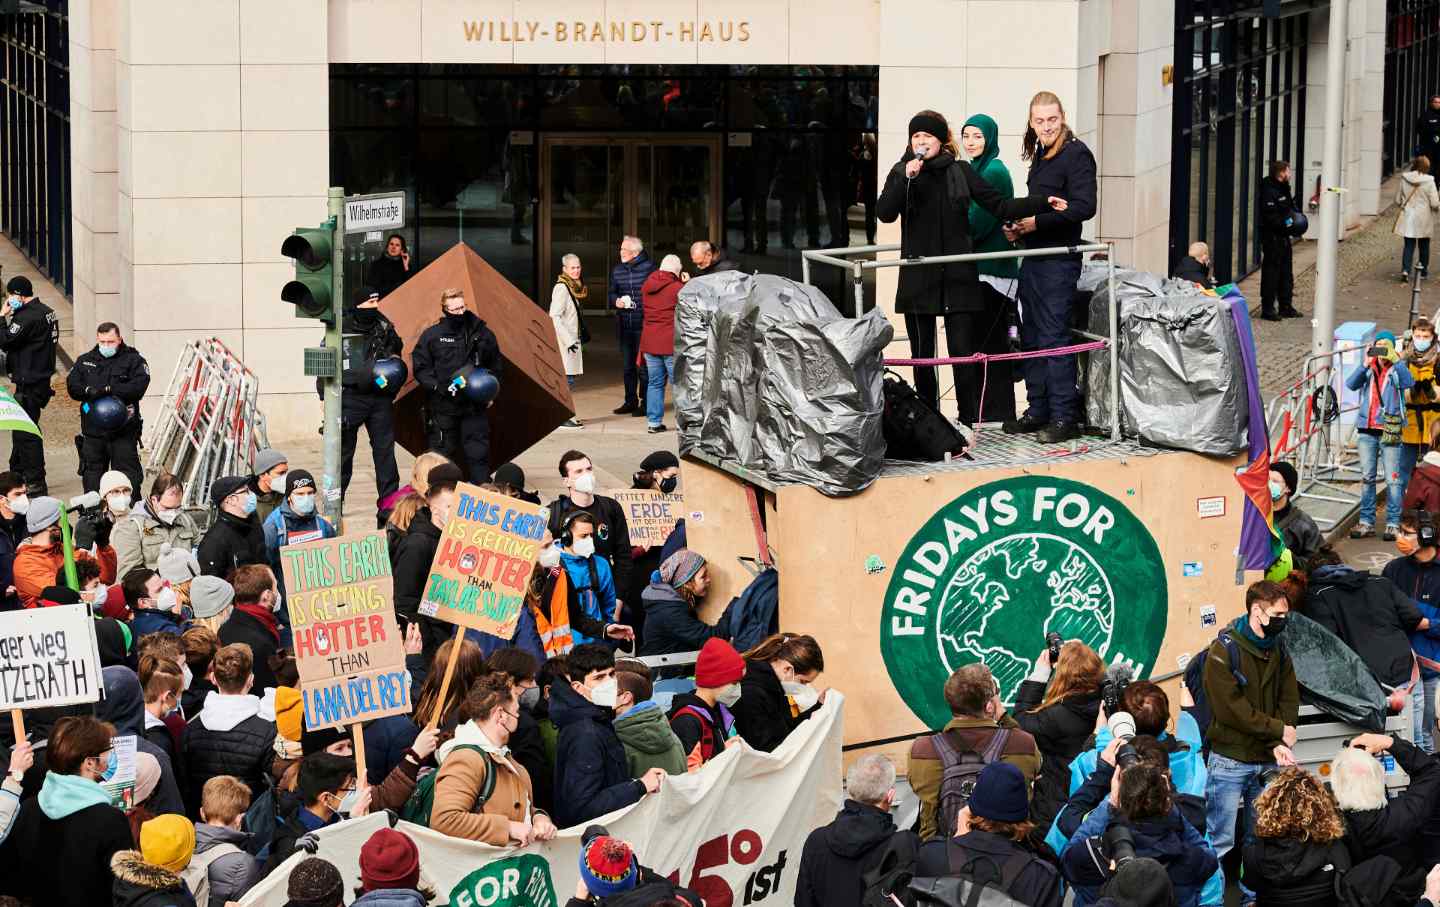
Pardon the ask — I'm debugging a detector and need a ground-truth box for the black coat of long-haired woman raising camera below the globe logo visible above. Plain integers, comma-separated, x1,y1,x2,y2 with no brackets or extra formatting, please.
1011,681,1100,828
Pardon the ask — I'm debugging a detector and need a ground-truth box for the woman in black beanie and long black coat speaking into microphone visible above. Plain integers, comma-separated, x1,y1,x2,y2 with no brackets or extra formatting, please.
876,111,1066,425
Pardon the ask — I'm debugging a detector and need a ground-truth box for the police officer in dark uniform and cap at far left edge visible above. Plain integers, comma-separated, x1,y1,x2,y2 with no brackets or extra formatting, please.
0,276,60,497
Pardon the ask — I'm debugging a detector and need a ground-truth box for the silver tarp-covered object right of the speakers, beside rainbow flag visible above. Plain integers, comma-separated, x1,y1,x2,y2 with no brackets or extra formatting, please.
1080,265,1250,456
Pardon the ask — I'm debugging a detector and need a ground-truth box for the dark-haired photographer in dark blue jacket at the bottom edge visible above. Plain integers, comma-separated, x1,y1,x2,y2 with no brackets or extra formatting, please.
1060,762,1220,907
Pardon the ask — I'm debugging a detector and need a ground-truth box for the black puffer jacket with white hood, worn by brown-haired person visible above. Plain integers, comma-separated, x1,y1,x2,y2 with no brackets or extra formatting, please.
184,692,275,815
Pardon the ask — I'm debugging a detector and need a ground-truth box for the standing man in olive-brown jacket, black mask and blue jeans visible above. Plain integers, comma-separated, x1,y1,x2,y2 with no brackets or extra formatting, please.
1204,580,1300,897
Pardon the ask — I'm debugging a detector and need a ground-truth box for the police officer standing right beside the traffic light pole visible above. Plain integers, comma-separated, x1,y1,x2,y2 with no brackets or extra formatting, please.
340,286,402,509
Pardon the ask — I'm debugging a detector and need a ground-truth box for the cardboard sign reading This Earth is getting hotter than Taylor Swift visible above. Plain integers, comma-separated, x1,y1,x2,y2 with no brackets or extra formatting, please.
419,482,546,639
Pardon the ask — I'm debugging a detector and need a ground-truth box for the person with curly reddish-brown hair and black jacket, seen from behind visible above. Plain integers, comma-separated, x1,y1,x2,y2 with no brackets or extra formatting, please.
1244,769,1351,907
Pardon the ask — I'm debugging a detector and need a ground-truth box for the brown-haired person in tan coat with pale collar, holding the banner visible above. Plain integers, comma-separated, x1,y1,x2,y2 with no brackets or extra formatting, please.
431,674,556,847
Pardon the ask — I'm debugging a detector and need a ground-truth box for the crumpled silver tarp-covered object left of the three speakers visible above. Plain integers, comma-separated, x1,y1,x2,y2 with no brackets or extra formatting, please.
675,271,894,495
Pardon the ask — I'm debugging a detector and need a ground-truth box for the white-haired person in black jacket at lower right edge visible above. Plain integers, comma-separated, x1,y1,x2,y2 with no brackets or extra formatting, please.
1331,734,1440,894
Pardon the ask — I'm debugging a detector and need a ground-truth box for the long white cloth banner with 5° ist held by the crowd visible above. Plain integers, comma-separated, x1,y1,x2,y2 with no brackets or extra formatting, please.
240,690,844,907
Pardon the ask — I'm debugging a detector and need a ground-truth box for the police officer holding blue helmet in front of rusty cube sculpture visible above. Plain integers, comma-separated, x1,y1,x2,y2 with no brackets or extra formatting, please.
410,289,503,482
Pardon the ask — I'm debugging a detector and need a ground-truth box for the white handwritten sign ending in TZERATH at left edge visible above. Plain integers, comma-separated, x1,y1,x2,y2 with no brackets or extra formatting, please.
0,605,101,708
